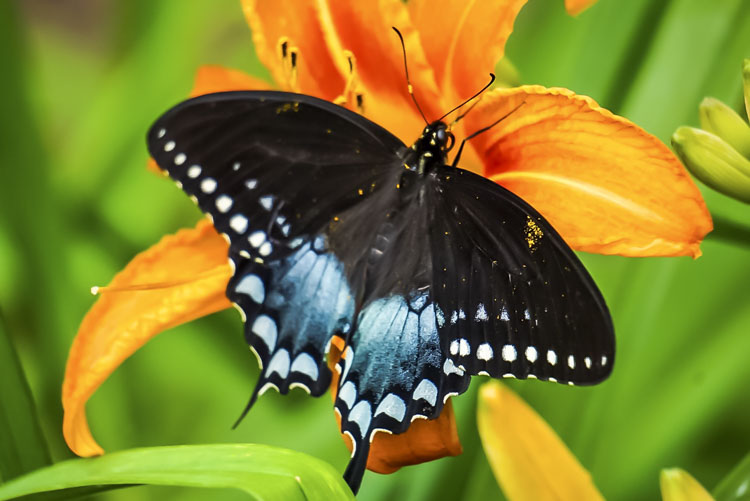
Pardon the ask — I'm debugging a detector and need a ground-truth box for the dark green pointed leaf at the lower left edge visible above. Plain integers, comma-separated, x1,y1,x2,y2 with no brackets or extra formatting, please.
0,308,52,481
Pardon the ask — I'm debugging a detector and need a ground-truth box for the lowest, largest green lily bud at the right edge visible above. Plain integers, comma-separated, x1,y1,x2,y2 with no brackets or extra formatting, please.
672,127,750,203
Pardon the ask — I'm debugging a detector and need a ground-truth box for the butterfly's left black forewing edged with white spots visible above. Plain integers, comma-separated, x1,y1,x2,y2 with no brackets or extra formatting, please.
148,91,404,260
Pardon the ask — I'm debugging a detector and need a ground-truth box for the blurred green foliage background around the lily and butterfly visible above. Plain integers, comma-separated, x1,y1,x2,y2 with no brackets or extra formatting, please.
0,0,750,501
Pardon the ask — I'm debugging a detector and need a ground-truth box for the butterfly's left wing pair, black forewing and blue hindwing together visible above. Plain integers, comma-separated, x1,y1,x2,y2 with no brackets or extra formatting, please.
148,92,405,403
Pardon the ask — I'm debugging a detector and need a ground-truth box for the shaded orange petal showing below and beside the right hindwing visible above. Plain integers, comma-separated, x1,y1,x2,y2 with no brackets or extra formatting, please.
328,337,462,473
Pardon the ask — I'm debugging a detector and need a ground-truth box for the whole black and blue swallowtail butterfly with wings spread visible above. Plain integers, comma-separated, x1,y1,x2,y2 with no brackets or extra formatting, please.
147,87,614,493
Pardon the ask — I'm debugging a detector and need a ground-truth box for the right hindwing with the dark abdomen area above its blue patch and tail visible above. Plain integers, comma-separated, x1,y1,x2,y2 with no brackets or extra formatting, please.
331,166,469,492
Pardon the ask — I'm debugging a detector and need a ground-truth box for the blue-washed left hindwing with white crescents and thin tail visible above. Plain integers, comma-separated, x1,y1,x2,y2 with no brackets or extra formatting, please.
227,238,354,410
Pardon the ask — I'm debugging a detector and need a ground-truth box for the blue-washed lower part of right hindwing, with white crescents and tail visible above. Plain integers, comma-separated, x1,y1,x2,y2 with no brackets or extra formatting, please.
335,292,469,489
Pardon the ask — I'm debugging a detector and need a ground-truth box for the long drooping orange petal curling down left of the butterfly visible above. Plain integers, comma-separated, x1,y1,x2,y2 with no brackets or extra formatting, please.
62,220,231,457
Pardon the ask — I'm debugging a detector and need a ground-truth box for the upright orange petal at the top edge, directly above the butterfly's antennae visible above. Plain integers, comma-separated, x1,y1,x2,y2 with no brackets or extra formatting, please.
409,0,526,104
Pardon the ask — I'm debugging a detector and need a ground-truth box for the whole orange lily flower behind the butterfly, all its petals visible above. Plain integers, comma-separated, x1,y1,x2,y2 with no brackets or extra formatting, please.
63,0,712,484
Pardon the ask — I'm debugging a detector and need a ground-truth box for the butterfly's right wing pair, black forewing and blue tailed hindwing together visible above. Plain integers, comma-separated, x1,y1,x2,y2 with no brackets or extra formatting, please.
335,161,614,490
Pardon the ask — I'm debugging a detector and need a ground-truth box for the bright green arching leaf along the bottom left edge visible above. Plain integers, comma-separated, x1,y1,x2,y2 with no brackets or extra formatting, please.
0,444,354,501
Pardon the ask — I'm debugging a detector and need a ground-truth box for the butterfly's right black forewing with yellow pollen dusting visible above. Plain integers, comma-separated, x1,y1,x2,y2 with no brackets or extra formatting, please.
430,166,614,385
